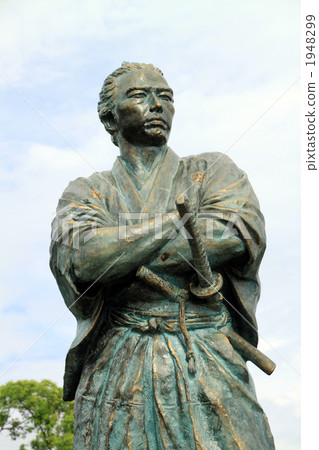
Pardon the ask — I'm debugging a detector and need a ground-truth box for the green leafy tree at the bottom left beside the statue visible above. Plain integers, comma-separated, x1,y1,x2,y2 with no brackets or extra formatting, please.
0,380,73,450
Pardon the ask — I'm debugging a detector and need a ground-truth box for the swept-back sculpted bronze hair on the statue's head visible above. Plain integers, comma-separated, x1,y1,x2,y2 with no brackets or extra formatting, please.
97,61,163,145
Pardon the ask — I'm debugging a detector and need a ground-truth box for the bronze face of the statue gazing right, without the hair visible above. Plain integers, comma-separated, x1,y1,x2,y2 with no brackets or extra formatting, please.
114,70,175,146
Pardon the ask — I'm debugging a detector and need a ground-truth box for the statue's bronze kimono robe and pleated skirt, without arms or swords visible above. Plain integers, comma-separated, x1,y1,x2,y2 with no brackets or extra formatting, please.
50,148,274,450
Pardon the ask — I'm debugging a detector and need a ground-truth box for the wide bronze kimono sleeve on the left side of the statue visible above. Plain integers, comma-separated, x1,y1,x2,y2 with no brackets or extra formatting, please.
50,176,113,346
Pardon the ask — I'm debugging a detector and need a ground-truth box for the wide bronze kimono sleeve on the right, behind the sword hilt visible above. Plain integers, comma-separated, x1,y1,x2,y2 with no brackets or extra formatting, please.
199,153,266,345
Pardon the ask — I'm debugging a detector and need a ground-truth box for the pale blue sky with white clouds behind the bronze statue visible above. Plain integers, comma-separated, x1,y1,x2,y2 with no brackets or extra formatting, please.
0,0,300,450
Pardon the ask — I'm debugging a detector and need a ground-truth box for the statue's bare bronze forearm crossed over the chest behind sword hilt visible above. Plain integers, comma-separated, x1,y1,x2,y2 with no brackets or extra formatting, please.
73,211,245,282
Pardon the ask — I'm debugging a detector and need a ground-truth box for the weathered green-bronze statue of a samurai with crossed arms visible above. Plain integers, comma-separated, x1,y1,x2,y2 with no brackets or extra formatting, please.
50,63,274,450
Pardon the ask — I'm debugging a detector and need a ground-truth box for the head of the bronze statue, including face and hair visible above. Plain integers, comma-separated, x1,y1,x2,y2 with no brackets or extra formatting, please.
98,62,174,146
